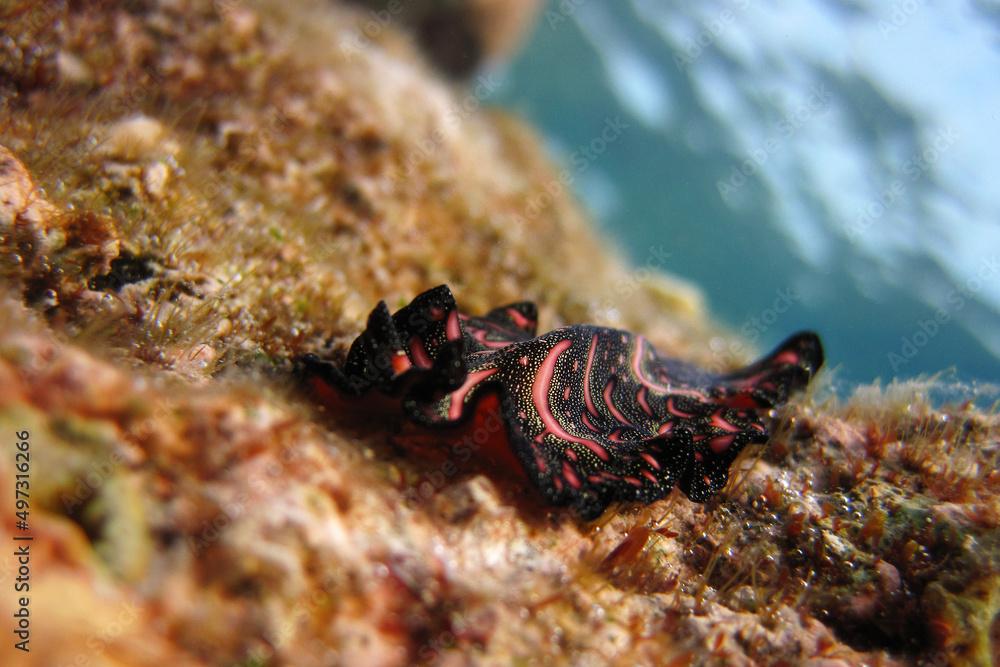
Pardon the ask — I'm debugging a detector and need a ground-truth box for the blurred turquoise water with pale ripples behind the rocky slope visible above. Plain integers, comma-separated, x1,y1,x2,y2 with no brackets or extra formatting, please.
489,0,1000,388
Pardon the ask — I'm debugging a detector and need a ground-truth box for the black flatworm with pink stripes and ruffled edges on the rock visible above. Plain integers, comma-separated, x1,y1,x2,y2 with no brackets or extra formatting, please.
300,285,823,519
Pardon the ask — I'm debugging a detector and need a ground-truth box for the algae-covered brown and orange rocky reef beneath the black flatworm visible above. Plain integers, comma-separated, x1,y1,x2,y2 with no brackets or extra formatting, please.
0,0,1000,666
